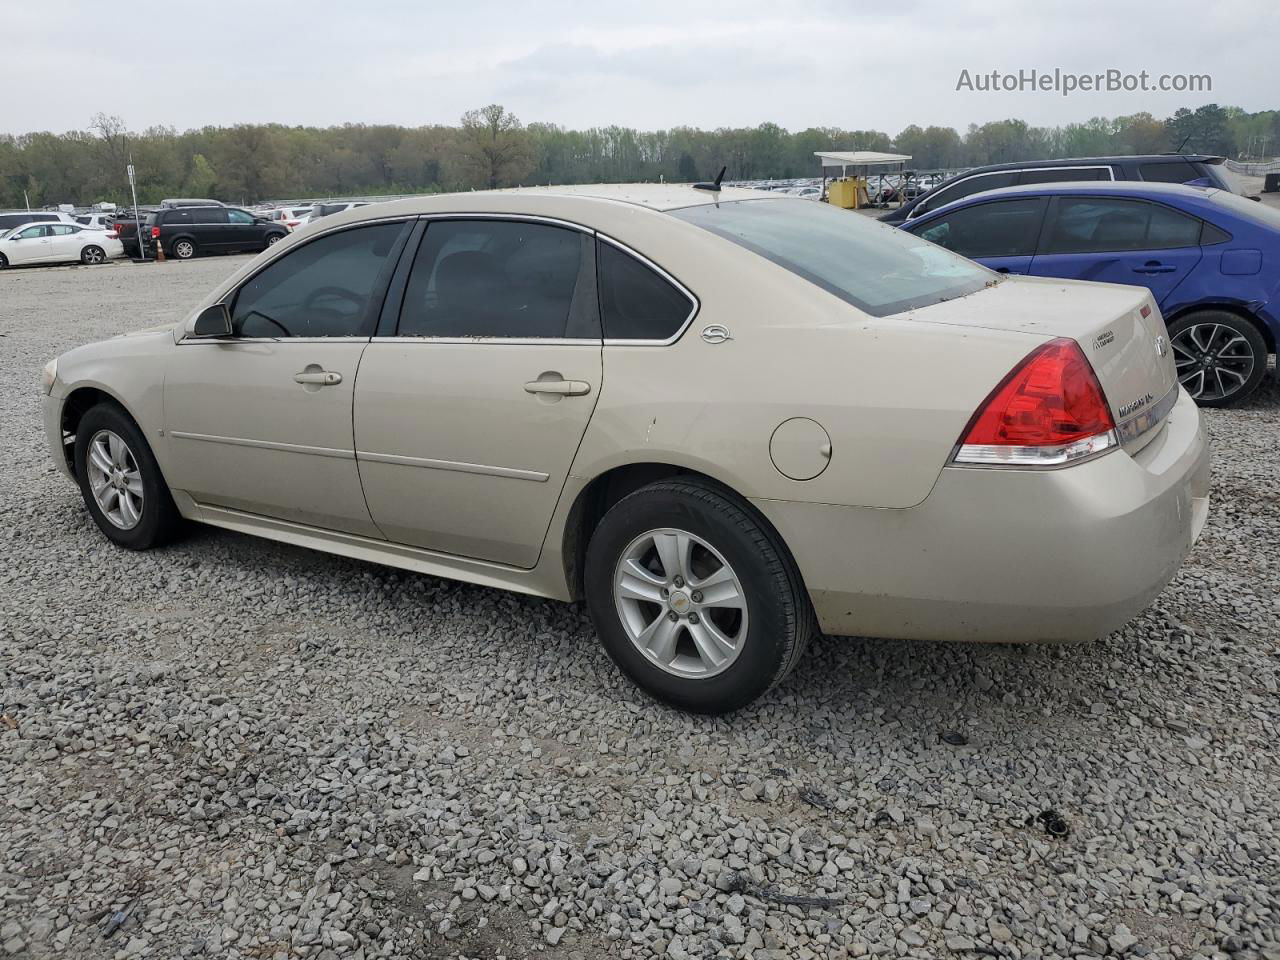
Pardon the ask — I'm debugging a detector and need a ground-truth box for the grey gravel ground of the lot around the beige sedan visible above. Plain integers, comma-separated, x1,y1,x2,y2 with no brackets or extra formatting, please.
0,259,1280,960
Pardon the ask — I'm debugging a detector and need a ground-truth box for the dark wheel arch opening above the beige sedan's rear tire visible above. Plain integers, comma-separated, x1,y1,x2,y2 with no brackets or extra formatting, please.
561,461,808,600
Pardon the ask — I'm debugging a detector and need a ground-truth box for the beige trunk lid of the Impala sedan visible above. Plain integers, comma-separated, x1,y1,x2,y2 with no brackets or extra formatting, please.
902,276,1178,453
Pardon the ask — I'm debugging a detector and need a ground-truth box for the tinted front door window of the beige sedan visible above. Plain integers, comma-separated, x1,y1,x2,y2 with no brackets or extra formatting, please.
232,223,406,338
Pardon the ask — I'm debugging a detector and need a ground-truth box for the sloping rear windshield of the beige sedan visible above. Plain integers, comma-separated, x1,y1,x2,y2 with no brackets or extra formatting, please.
671,200,995,316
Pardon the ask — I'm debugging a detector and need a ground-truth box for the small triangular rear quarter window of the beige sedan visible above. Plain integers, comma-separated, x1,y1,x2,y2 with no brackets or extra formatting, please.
596,241,694,340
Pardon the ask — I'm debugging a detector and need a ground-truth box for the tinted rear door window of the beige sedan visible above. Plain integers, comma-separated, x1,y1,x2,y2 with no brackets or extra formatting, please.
398,220,600,339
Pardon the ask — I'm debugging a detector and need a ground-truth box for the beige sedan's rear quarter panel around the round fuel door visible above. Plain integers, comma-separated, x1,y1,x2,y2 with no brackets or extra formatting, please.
572,219,1046,507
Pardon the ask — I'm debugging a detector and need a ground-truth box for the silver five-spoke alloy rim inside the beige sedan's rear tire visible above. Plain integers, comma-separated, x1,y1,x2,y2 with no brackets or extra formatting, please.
613,527,748,678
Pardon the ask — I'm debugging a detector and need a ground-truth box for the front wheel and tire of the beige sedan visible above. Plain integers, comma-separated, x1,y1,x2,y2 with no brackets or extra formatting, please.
76,403,182,550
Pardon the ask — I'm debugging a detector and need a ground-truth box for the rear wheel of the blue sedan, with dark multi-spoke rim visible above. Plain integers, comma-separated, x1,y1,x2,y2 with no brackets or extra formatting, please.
1169,310,1267,407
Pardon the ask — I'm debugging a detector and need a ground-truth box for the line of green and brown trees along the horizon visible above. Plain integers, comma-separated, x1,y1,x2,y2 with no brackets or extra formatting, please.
0,104,1280,207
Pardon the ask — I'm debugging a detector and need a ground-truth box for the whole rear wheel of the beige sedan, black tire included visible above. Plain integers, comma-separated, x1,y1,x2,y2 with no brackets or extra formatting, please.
585,480,813,714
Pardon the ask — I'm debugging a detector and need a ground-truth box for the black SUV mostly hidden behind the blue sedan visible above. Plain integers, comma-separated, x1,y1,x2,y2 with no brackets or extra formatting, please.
879,154,1240,224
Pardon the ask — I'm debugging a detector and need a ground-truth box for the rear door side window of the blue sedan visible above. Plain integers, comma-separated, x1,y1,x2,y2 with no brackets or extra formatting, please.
1039,197,1201,253
